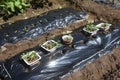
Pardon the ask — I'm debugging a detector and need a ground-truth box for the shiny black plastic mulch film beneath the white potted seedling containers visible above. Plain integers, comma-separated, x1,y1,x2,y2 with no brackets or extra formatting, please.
0,7,120,80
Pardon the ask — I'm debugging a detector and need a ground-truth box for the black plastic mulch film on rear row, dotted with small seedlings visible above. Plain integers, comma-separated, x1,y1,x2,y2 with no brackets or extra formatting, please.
0,8,86,45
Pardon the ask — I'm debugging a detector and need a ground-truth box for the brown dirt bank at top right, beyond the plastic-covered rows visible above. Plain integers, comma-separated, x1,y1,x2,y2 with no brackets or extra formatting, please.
70,0,120,24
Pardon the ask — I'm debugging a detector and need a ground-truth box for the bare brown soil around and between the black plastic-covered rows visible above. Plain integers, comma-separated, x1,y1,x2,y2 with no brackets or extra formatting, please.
0,0,120,80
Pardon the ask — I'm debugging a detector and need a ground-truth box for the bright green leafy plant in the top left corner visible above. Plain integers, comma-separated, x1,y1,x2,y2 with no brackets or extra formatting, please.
0,0,30,15
